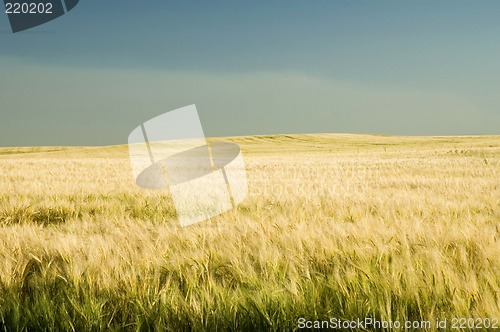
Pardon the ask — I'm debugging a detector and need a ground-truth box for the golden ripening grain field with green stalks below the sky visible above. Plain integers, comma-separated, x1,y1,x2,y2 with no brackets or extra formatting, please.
0,134,500,331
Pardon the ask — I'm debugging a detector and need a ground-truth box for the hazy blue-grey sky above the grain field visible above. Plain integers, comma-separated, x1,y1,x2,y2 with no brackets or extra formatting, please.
0,0,500,146
